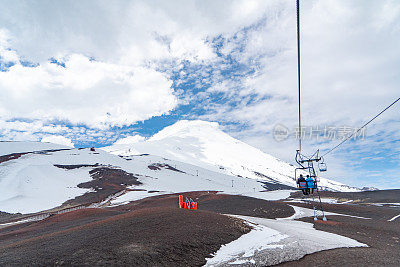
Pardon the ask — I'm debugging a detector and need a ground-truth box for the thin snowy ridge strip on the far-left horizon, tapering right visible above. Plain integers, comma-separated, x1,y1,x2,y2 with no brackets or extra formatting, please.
0,141,70,156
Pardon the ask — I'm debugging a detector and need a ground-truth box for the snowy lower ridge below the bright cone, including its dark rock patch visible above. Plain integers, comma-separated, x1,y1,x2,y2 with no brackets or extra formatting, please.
0,142,290,215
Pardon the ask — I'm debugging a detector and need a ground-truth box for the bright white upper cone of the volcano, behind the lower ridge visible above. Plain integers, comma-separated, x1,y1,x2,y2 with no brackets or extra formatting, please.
103,120,359,191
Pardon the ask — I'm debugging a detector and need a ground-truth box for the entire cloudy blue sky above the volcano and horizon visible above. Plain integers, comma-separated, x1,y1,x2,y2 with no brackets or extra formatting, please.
0,0,400,188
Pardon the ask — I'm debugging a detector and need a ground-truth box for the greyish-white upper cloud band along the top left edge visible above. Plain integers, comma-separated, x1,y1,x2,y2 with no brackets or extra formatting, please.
0,0,270,65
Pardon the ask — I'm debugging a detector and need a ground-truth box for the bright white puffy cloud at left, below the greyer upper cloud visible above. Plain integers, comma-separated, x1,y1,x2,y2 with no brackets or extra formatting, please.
0,54,177,128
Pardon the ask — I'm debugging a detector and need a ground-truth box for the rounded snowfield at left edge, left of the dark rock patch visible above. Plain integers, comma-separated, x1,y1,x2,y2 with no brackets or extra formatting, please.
0,154,91,213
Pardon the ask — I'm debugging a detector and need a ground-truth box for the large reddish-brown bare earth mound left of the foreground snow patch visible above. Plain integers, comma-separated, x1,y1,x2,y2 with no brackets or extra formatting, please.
0,192,293,266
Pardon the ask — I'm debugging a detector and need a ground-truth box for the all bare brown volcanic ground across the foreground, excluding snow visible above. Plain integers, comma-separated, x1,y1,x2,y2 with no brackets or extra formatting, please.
0,191,400,266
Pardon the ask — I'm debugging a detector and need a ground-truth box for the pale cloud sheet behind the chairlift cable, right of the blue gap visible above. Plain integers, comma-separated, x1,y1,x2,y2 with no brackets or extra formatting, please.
192,1,400,187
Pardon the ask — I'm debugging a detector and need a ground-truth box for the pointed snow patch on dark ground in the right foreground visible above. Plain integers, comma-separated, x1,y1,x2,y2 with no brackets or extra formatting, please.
206,215,367,266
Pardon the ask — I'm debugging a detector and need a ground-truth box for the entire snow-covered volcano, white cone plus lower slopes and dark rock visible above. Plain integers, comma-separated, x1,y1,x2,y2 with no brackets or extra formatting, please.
0,121,358,213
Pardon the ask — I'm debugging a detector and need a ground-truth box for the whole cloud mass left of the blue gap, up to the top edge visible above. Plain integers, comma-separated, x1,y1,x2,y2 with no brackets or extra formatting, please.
0,0,274,129
